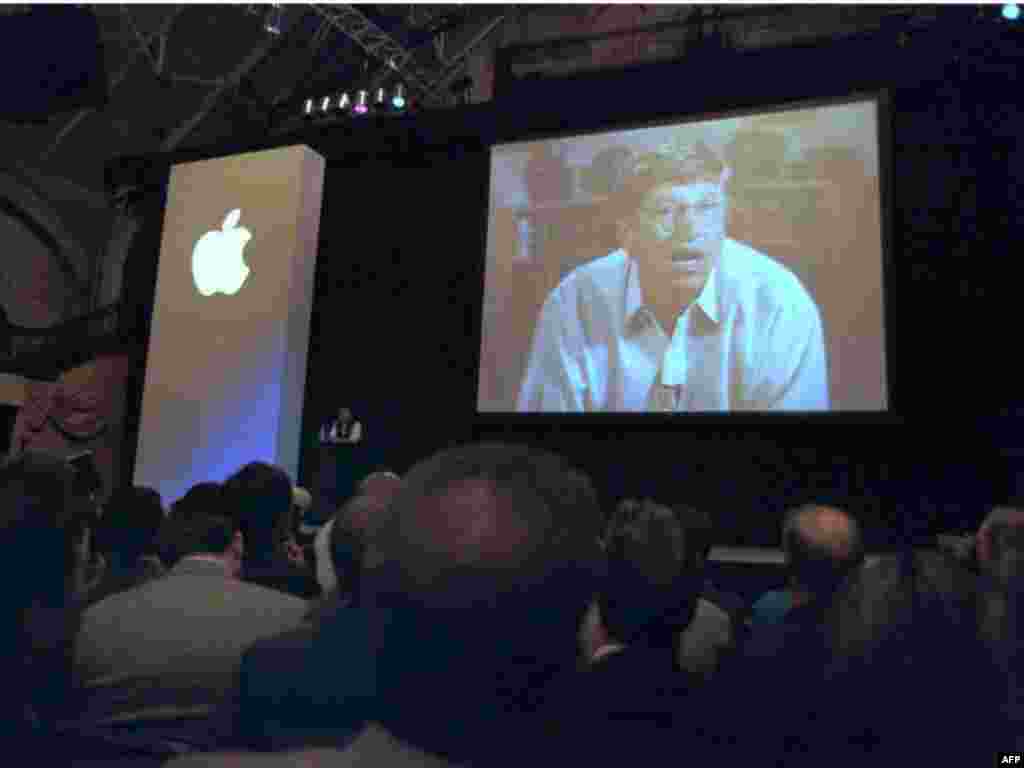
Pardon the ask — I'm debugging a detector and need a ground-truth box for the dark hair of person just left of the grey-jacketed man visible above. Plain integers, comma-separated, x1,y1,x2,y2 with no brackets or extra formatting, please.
95,485,164,565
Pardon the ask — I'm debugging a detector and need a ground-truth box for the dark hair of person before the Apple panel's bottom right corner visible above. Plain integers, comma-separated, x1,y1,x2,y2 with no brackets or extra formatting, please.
222,462,294,560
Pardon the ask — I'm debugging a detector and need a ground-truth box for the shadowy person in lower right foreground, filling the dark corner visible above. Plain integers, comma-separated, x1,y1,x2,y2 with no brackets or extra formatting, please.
707,551,1007,768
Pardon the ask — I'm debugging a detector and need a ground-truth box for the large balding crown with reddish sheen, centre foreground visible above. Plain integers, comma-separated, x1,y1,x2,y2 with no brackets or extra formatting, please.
368,444,601,618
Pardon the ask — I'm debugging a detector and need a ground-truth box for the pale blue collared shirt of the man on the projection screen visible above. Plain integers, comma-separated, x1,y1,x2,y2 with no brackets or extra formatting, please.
516,240,828,413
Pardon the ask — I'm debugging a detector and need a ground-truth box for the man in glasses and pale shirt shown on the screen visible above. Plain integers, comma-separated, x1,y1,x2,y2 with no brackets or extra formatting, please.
516,141,828,412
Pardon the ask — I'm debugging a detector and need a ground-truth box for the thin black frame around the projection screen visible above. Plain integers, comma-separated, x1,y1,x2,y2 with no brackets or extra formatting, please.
474,88,892,431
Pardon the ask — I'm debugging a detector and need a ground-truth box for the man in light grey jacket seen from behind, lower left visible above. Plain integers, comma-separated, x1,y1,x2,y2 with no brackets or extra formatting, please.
76,510,307,750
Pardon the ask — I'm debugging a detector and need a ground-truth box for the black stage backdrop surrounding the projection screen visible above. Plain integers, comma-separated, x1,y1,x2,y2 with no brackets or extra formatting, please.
110,13,1024,547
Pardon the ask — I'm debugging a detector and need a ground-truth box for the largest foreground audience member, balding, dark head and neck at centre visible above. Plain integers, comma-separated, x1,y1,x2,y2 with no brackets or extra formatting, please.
167,444,606,767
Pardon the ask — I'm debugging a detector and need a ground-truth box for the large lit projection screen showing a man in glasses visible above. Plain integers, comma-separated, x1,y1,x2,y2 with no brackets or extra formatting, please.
477,96,888,414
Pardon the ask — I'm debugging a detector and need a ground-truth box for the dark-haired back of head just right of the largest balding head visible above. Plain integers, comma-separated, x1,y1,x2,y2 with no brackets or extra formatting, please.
600,500,700,646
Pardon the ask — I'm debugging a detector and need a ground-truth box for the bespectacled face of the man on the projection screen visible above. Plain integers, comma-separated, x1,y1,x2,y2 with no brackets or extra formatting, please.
625,174,726,303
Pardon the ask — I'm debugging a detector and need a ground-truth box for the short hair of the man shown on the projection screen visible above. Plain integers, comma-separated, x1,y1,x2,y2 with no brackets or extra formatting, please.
615,139,725,217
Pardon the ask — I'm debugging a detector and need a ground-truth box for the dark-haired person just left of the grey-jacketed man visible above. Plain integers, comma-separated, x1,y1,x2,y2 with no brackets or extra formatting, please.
88,486,165,603
